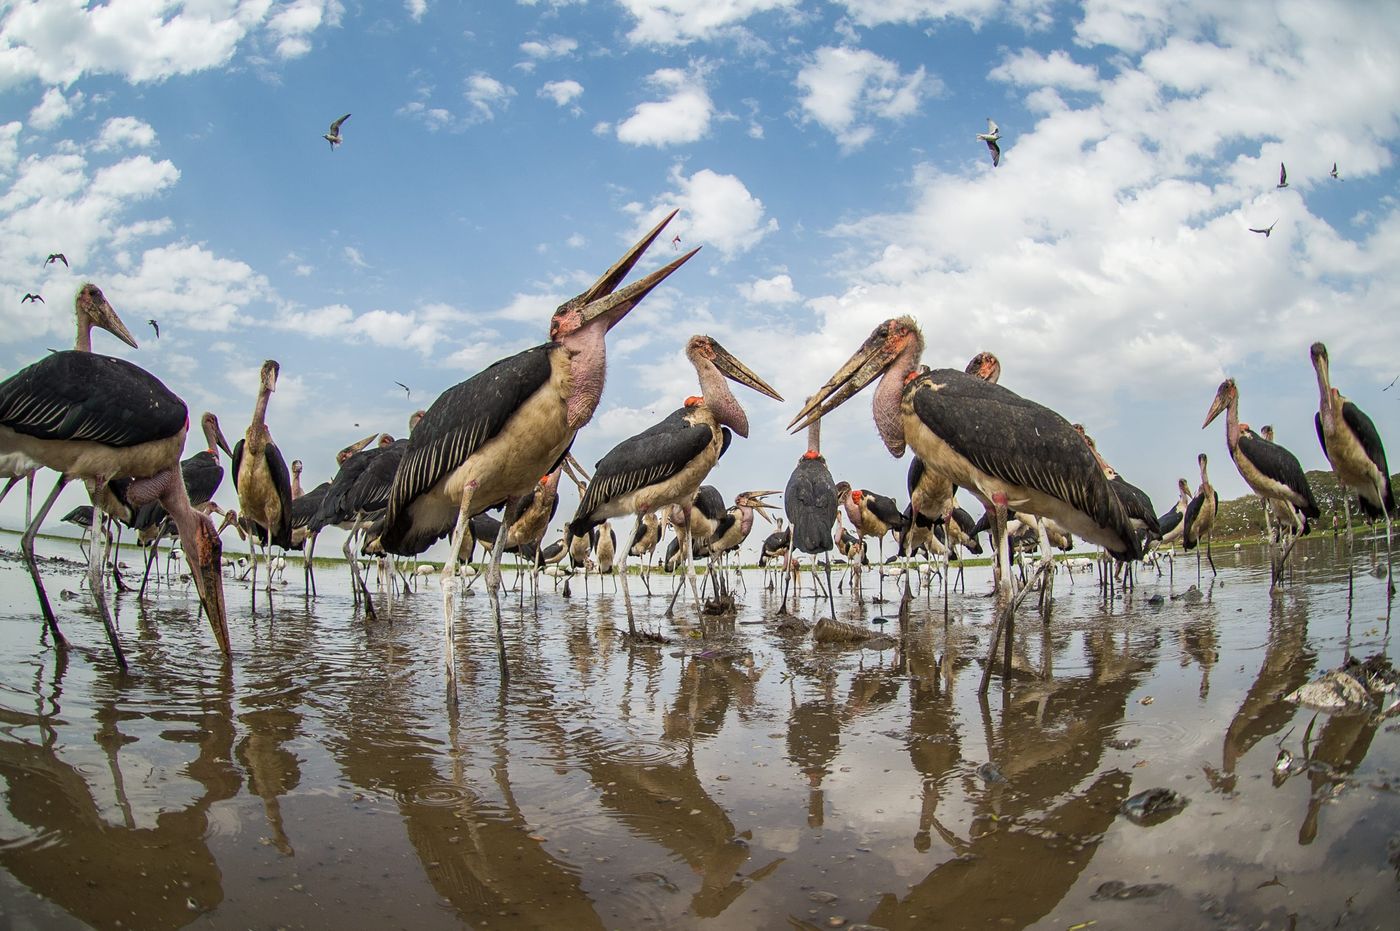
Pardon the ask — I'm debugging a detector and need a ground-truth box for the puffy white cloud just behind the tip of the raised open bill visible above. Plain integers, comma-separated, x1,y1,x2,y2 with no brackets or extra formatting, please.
631,165,778,256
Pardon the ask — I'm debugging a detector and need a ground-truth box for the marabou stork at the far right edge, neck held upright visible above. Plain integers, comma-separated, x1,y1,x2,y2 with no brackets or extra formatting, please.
1309,343,1396,592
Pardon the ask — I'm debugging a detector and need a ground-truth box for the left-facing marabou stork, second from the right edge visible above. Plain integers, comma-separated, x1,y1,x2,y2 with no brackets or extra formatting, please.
1201,378,1322,585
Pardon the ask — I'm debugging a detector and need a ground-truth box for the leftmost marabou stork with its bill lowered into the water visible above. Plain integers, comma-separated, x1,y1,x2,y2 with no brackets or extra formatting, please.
0,351,228,660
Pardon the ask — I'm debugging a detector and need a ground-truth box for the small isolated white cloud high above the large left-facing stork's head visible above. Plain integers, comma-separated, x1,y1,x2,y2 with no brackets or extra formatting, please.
797,46,938,150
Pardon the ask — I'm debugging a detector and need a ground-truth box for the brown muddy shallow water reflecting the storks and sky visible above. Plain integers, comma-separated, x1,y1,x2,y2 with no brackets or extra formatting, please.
0,536,1400,928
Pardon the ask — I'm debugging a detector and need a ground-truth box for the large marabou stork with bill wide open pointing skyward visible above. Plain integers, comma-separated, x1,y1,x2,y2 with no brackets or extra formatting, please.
379,211,699,680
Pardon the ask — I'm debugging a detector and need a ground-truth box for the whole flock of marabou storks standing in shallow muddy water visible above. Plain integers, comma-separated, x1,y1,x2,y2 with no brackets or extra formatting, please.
0,213,1394,694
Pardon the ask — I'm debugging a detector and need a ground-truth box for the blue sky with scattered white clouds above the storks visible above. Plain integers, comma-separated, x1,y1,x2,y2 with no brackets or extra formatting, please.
0,0,1400,560
